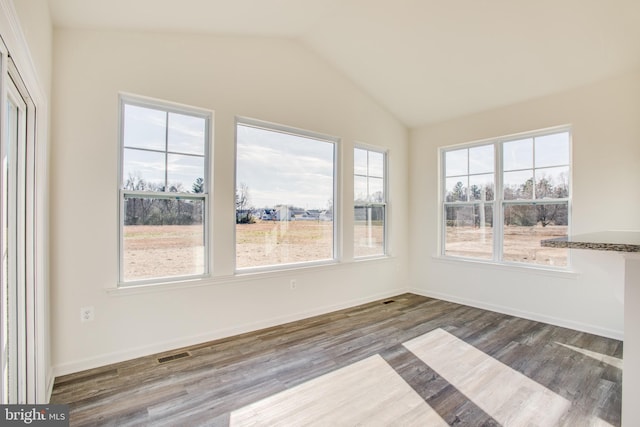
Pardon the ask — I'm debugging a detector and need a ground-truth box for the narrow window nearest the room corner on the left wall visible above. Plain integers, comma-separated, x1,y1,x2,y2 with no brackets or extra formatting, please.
353,148,387,257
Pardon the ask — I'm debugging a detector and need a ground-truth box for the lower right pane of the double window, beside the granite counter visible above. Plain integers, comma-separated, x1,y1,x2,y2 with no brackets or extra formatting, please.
503,203,568,266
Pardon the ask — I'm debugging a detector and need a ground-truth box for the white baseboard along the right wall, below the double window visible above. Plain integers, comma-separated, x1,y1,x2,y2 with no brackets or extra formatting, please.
408,288,624,341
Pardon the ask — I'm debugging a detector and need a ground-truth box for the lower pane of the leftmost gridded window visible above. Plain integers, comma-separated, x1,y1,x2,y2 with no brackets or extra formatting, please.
123,197,205,281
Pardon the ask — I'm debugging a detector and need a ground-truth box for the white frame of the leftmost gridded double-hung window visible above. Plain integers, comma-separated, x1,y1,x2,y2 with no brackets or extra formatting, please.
118,93,213,287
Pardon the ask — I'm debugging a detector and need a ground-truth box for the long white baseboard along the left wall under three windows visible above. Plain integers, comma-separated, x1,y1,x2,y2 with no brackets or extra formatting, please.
49,289,408,380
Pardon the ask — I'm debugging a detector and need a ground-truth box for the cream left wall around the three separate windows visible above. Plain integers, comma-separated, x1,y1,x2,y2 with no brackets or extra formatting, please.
50,30,409,375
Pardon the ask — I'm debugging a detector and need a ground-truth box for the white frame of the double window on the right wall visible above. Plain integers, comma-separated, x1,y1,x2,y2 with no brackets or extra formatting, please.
438,125,573,271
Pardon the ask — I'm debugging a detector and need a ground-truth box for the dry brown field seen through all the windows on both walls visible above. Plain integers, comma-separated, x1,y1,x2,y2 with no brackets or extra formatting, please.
123,221,567,280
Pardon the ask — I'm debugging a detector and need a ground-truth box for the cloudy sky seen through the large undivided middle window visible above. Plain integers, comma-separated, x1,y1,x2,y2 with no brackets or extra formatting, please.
236,125,335,209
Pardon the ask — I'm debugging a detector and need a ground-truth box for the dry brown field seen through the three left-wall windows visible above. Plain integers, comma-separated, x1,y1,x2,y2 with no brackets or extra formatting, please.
124,221,383,280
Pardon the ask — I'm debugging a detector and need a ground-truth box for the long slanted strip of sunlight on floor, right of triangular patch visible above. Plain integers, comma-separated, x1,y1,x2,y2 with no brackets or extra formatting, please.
404,329,571,426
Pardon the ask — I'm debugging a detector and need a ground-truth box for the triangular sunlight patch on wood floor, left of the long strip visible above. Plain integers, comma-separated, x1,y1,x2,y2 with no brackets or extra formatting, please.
229,355,447,427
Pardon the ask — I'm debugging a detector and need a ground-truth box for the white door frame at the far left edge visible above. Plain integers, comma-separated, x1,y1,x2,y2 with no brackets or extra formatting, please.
0,0,54,404
